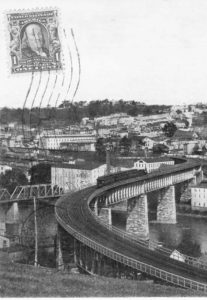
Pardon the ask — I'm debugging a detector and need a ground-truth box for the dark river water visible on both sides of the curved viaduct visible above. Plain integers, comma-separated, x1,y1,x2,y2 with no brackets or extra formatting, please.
10,205,207,267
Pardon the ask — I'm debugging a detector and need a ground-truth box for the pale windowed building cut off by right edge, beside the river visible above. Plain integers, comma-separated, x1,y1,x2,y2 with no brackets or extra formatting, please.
191,180,207,210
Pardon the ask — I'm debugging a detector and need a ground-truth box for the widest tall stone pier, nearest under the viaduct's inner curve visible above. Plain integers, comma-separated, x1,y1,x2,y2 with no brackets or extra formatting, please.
126,194,149,240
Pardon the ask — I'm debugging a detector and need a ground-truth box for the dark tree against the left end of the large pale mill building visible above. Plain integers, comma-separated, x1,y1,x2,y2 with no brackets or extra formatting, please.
29,163,51,184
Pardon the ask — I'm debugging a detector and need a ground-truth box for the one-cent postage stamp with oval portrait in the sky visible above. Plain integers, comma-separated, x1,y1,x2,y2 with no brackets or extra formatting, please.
7,10,62,73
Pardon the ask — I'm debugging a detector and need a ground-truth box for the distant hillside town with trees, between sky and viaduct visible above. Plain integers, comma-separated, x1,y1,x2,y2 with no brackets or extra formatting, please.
0,100,207,195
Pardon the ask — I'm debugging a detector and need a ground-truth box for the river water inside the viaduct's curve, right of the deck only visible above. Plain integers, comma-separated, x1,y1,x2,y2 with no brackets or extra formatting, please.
112,212,207,259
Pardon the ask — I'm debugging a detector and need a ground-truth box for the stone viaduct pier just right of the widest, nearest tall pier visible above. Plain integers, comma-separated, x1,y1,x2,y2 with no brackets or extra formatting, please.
157,185,177,224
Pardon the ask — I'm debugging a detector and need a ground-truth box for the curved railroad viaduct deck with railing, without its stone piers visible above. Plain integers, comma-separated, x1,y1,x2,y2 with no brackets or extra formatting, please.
55,162,207,293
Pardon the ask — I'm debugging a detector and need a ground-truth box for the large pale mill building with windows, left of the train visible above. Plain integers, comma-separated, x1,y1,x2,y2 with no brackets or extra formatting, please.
51,162,106,191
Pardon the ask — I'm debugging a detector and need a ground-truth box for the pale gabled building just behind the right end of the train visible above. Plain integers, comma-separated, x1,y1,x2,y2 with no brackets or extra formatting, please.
134,157,174,173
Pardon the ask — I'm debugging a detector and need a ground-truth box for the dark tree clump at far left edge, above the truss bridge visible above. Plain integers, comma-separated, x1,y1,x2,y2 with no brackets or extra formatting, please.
0,168,28,193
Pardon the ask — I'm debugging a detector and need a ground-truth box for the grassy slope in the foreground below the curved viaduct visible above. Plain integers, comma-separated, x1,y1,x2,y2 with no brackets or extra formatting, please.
0,252,203,297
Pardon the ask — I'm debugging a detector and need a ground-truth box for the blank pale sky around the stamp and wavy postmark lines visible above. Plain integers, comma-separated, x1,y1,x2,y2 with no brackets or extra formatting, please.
0,0,207,107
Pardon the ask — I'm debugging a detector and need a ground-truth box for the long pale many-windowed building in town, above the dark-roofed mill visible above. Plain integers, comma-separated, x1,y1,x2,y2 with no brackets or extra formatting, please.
41,134,96,151
